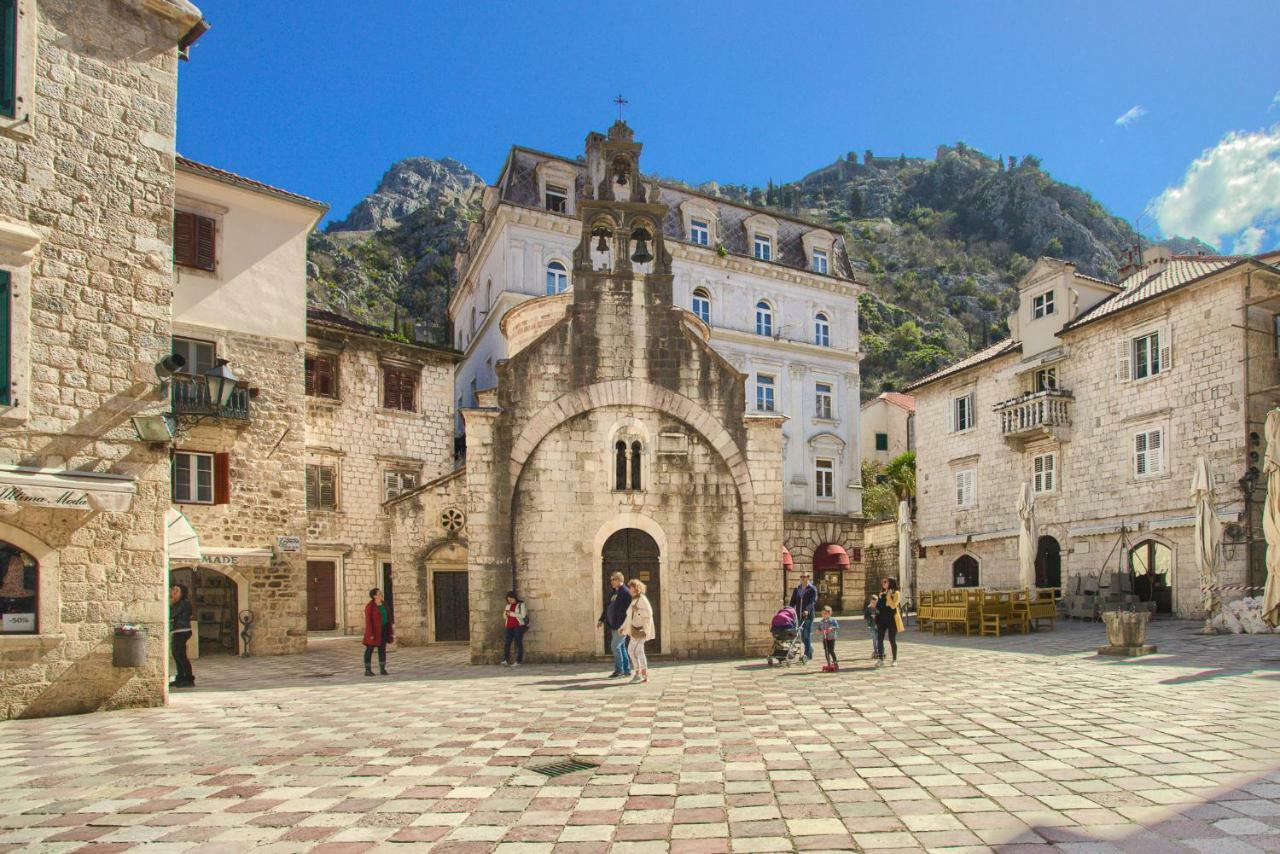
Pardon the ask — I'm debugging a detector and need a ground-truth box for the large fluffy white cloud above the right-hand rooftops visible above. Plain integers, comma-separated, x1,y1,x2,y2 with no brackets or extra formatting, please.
1152,124,1280,254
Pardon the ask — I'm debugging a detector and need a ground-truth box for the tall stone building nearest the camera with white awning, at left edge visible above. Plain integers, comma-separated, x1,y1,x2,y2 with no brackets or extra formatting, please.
0,0,204,718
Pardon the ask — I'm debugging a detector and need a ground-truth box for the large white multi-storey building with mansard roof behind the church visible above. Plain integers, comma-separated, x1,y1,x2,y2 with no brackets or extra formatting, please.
449,126,863,607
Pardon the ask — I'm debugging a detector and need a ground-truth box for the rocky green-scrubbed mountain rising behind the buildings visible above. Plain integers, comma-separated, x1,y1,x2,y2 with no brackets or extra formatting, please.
302,143,1212,396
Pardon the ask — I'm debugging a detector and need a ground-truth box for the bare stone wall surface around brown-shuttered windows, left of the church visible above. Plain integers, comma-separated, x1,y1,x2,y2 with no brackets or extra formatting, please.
300,310,457,632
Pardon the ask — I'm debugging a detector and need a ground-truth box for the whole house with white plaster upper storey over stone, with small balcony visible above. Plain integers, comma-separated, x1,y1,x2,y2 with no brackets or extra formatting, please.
169,157,328,656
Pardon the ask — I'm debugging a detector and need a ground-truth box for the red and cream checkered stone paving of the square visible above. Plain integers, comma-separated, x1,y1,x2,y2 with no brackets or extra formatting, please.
0,621,1280,854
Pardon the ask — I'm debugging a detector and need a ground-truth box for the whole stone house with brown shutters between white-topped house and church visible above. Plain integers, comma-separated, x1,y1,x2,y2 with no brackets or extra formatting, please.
298,309,458,643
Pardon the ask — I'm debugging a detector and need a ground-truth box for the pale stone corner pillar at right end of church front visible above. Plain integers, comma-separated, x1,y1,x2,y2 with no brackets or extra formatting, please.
742,415,786,656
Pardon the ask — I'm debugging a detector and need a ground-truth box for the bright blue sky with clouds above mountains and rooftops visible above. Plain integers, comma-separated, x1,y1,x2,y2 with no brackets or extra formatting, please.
178,0,1280,251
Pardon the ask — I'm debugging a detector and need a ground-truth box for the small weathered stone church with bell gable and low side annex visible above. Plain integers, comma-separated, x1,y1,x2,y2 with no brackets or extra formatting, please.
389,122,785,662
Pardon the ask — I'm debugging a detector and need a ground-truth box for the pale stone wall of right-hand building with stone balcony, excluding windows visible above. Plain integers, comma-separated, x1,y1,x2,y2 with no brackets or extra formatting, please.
916,273,1275,617
